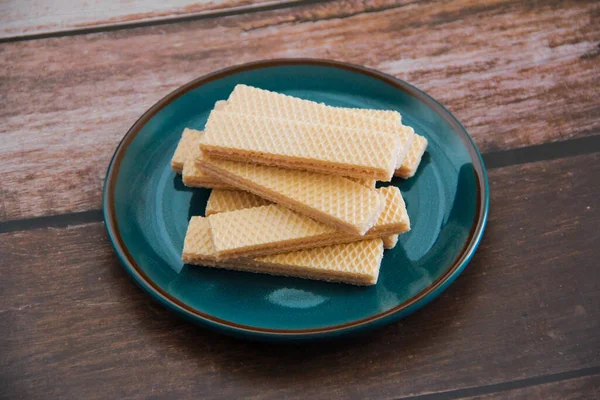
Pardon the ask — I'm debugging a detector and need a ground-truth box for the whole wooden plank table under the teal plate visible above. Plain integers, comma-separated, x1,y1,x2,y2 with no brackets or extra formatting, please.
0,0,600,399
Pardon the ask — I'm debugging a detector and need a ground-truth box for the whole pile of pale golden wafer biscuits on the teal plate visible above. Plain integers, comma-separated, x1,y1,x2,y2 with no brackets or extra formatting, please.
171,85,427,285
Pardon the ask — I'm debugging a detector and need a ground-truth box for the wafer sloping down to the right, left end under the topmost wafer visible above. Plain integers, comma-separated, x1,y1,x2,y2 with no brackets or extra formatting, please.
198,158,385,235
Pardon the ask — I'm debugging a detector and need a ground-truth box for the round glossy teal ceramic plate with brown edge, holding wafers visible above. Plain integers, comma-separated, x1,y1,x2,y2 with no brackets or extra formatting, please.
104,59,489,339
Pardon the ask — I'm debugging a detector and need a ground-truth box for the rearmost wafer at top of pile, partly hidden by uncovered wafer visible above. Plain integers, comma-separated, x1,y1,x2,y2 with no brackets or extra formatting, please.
223,84,414,168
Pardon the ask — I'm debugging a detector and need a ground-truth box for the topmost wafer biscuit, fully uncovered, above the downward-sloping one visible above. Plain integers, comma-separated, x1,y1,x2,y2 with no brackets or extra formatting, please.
200,111,408,181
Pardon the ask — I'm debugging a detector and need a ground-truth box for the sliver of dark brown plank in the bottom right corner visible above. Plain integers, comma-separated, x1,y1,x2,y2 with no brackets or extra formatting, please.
464,375,600,400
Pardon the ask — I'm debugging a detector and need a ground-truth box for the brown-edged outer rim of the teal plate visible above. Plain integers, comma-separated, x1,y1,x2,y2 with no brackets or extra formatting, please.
102,58,490,339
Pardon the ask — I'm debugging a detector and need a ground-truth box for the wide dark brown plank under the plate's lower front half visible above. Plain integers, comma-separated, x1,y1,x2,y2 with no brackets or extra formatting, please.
0,153,600,399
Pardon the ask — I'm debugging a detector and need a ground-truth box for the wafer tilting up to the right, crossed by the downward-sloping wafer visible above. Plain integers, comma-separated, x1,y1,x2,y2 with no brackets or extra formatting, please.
208,186,410,259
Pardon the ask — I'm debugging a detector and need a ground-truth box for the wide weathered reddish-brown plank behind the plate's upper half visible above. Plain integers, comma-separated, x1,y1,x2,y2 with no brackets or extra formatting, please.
0,0,600,220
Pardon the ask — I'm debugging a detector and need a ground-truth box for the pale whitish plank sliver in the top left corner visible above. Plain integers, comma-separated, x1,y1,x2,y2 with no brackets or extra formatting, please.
0,0,286,39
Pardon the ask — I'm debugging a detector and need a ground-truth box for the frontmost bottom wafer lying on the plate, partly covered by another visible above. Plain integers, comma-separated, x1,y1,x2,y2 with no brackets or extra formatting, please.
182,217,383,285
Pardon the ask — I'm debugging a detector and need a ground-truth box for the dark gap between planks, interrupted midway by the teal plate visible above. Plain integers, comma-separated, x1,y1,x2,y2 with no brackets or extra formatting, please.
0,135,600,233
